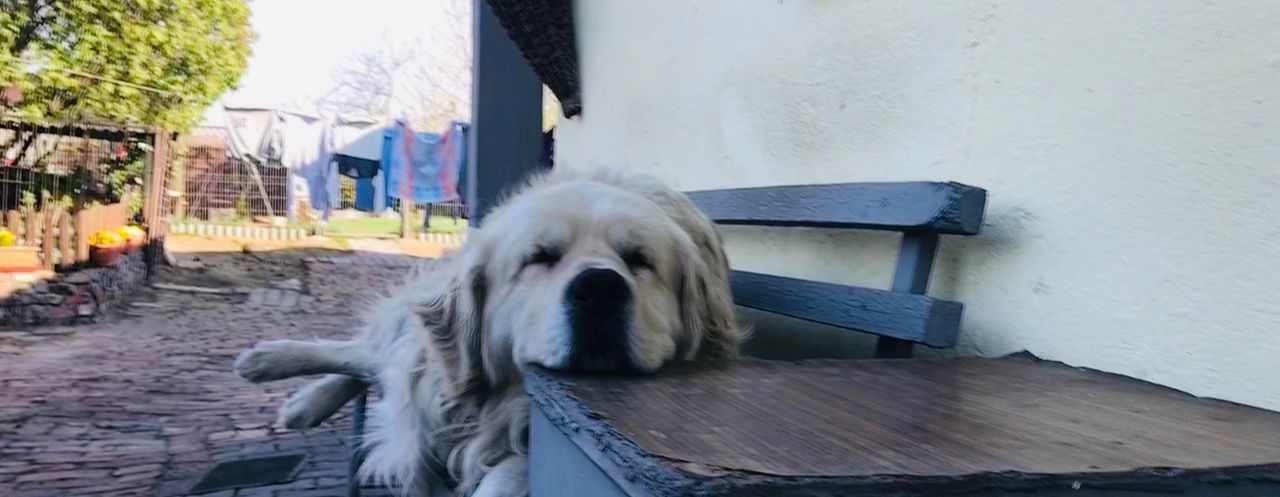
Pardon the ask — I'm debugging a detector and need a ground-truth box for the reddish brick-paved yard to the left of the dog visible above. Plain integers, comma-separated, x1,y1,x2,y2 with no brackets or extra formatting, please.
0,244,432,497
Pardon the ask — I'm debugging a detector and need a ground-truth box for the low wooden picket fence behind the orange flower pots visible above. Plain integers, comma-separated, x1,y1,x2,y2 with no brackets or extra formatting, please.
3,204,128,269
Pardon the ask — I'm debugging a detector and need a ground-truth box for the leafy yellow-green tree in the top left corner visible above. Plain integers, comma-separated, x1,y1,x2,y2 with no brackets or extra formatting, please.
0,0,255,131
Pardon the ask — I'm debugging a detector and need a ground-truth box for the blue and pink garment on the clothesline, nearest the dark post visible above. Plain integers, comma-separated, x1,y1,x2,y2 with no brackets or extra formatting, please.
383,120,466,204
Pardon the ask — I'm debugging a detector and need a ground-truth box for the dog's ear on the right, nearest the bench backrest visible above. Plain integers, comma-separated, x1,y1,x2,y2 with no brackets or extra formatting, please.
677,232,745,360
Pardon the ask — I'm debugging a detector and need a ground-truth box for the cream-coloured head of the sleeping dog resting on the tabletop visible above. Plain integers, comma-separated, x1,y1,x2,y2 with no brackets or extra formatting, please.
440,173,742,383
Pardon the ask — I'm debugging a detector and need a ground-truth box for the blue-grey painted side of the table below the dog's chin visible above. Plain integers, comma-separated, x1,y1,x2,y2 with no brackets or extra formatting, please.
529,406,627,497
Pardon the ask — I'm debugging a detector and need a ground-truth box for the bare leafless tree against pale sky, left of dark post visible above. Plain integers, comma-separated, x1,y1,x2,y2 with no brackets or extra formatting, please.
316,0,471,131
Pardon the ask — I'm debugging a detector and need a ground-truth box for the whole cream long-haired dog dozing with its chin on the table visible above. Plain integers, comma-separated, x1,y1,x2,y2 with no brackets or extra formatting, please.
236,170,744,497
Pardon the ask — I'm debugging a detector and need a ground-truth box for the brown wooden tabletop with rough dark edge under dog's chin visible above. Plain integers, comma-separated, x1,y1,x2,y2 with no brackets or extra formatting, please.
525,359,1280,497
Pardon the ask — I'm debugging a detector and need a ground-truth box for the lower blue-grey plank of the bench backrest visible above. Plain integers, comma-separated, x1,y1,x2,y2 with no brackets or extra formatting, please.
731,272,964,347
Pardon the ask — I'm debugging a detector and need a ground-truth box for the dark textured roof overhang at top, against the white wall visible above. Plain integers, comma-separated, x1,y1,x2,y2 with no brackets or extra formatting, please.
488,0,582,118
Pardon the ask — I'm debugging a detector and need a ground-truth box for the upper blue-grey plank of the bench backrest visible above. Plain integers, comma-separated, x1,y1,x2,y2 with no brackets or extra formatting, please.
689,182,987,234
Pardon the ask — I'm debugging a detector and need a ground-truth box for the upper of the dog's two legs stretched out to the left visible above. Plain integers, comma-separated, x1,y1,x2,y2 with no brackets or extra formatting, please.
236,339,378,383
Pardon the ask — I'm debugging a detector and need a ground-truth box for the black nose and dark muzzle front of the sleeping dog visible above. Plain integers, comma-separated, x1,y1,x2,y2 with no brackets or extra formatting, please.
564,268,634,371
